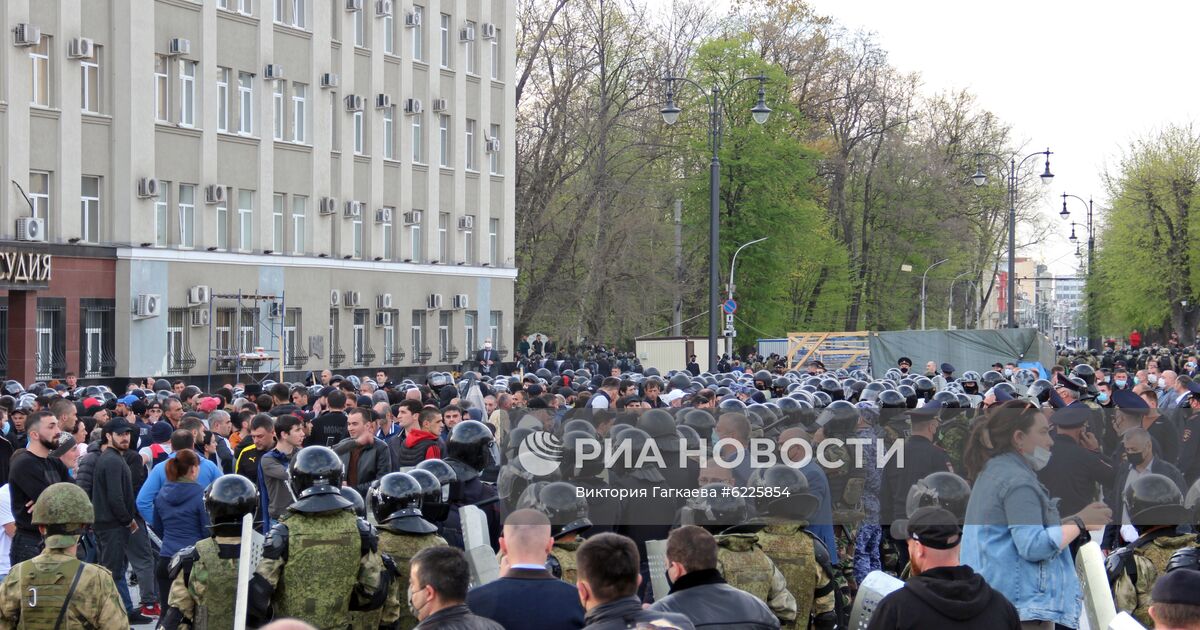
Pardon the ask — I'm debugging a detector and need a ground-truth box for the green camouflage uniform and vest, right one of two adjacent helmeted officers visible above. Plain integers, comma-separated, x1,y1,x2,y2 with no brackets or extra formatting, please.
757,521,838,628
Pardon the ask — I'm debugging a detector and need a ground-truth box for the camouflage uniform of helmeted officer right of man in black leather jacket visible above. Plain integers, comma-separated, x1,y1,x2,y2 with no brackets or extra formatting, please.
716,534,796,625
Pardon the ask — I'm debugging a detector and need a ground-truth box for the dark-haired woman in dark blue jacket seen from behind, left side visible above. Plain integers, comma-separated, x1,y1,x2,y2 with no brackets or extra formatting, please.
150,449,209,604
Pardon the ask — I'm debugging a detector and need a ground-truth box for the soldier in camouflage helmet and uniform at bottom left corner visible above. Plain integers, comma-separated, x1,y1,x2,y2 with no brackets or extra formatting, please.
0,482,130,630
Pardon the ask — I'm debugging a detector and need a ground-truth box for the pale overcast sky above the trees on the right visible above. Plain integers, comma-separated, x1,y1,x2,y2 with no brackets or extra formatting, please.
696,0,1200,274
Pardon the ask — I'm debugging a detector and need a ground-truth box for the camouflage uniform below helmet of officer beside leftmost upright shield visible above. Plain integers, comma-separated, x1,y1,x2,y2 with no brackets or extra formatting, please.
167,536,241,630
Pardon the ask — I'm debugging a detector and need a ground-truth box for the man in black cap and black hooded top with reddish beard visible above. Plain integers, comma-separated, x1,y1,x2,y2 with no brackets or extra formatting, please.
866,506,1021,630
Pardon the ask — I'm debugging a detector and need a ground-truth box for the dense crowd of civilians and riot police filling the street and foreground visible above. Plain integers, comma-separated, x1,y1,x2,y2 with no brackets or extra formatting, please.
7,346,1200,629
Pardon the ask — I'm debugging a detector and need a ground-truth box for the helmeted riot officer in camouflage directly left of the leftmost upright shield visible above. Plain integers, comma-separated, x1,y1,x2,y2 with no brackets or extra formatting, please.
162,475,258,630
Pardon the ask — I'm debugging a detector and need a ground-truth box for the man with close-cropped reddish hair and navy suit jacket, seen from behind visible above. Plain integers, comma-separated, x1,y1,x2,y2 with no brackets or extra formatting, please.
467,510,583,630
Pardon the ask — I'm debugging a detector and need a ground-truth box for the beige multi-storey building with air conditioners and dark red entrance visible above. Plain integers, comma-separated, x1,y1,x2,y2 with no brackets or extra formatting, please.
0,0,516,385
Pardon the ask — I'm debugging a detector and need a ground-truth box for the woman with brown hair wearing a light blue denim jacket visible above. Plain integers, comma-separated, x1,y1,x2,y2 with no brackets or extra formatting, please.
961,401,1111,630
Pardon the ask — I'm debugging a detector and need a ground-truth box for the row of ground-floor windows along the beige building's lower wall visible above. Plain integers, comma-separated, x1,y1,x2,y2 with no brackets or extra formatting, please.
167,308,504,373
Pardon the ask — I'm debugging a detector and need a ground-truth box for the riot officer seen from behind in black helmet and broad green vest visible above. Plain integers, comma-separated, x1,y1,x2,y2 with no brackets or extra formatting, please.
250,446,391,628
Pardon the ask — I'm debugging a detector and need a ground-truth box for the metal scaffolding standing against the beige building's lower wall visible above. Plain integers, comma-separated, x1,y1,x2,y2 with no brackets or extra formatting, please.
201,290,295,391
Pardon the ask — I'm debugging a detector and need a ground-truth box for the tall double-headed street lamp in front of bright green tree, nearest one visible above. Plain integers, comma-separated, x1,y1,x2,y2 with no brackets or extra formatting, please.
661,74,770,372
